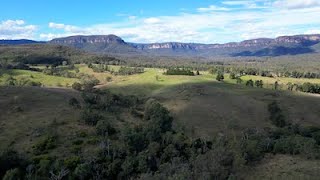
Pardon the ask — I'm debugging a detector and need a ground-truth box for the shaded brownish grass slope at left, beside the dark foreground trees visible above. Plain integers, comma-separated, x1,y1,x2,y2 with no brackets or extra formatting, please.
0,87,86,154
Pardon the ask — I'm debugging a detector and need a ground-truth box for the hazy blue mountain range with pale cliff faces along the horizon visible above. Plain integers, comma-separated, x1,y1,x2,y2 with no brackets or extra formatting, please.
0,34,320,57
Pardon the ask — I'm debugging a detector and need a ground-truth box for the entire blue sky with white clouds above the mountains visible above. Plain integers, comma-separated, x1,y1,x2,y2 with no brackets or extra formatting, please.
0,0,320,43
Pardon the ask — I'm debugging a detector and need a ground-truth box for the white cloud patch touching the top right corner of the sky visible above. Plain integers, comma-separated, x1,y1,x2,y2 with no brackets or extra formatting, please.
274,0,320,9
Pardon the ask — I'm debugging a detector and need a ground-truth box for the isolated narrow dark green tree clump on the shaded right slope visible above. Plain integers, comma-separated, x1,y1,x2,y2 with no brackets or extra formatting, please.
268,101,287,128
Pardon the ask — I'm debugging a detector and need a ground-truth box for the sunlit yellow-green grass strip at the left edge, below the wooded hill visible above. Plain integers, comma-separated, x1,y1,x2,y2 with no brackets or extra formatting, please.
0,69,78,87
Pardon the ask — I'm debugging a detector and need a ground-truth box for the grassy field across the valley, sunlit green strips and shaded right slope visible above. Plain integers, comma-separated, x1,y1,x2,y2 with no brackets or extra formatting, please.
0,65,320,136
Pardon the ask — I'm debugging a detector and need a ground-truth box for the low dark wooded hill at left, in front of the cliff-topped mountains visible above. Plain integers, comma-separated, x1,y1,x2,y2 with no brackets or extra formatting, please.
0,43,122,66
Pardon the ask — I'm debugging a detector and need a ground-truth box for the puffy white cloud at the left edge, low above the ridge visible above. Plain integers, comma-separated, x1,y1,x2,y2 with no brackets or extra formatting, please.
0,20,37,39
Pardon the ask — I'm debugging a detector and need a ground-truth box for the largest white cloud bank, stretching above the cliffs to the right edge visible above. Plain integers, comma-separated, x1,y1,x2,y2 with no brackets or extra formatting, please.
36,0,320,43
